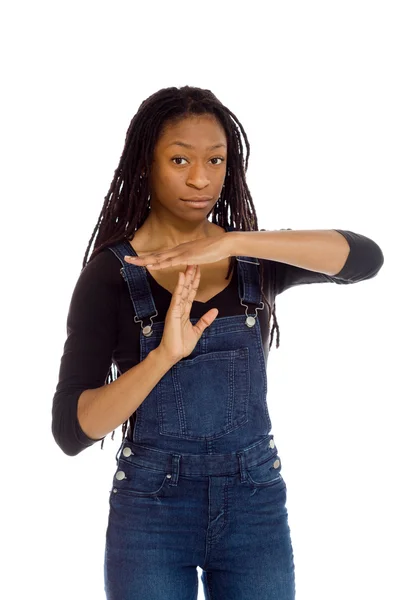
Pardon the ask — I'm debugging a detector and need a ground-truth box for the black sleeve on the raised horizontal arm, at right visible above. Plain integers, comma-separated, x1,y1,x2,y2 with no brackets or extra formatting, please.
263,229,384,296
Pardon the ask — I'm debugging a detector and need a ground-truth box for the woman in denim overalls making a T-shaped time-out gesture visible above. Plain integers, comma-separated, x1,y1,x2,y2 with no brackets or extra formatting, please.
52,87,383,600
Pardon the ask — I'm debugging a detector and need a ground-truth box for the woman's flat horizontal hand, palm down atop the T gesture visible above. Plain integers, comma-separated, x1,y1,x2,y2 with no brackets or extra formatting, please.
124,232,231,269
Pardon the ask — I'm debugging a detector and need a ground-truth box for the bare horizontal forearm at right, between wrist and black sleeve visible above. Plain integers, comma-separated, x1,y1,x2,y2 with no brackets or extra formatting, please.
226,229,350,276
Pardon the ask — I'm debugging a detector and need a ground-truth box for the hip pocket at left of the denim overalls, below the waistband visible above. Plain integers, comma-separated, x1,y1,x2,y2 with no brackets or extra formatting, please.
112,457,170,496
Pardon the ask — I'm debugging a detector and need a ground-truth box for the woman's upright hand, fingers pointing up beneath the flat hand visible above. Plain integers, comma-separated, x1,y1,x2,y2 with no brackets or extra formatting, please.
159,265,218,363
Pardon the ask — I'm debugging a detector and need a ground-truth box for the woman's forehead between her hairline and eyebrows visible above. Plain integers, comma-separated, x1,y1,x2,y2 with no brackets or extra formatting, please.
157,115,227,149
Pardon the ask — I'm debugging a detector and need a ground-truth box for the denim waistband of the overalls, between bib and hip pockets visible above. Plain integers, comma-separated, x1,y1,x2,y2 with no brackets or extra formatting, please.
116,433,278,477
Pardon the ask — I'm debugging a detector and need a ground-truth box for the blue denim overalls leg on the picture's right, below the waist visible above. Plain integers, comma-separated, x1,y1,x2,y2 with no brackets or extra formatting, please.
201,479,295,600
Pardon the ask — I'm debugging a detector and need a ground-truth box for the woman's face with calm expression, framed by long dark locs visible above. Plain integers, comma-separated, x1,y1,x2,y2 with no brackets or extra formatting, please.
150,115,227,221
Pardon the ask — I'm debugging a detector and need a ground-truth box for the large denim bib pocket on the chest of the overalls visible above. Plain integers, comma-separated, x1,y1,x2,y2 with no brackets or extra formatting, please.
157,348,250,440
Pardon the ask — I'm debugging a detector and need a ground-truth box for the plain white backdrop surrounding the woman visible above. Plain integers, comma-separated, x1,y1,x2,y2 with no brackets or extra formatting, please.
0,0,400,600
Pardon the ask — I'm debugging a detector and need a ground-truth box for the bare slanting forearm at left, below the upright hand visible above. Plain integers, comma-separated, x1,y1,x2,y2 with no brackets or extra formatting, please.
78,348,174,440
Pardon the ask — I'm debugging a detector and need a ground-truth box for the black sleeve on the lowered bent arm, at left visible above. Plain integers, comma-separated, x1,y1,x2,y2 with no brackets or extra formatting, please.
52,250,122,456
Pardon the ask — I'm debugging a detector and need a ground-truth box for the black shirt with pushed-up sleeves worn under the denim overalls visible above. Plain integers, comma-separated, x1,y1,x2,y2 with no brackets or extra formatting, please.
52,229,384,456
